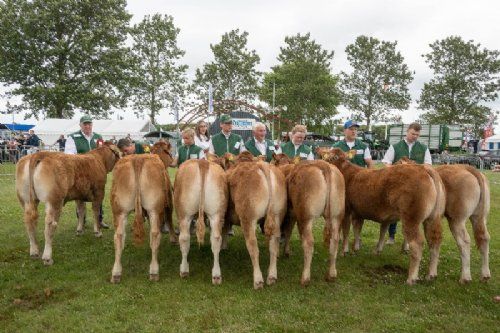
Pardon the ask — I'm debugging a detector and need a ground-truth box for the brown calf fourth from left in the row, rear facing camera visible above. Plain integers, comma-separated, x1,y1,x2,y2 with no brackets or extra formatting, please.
223,152,287,289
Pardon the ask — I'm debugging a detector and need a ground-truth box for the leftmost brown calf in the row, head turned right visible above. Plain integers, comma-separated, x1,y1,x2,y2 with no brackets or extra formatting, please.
16,144,120,265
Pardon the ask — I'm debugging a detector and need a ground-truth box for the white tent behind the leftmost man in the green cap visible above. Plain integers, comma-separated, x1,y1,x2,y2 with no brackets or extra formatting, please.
33,119,156,145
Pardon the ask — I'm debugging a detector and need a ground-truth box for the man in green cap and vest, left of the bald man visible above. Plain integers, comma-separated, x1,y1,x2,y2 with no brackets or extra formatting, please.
208,114,246,157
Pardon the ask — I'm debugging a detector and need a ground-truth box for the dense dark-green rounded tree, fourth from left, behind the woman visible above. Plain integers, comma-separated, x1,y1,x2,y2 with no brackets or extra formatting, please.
259,33,340,130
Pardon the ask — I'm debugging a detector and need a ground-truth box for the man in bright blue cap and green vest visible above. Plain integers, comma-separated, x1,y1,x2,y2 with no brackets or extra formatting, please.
333,120,374,169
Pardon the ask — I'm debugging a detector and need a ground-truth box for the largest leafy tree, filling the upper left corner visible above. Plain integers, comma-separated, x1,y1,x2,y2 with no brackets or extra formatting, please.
0,0,130,118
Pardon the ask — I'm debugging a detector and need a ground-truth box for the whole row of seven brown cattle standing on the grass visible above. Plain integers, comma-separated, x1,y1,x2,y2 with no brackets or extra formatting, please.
16,142,490,289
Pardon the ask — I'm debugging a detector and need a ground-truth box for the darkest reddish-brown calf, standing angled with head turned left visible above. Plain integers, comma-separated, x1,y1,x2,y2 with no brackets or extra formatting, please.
321,148,446,284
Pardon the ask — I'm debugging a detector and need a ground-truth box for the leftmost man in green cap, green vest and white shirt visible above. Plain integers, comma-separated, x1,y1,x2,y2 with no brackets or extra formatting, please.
64,115,109,229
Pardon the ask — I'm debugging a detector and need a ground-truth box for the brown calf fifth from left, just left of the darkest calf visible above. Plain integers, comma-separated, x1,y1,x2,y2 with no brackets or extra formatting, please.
286,161,345,286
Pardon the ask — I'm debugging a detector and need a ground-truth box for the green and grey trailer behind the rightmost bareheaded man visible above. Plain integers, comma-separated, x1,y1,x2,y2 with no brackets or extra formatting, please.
388,124,463,153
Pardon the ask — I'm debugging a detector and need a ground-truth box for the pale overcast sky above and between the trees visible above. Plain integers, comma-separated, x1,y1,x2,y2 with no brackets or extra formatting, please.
0,0,500,128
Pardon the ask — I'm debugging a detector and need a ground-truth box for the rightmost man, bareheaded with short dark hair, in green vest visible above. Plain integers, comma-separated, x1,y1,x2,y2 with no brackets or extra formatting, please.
382,123,432,244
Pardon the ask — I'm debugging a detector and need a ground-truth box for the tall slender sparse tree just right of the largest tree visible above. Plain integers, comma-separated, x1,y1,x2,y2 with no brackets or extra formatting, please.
131,14,188,123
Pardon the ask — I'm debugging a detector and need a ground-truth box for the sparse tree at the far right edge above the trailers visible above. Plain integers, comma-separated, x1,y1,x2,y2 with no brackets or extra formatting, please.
419,36,500,134
